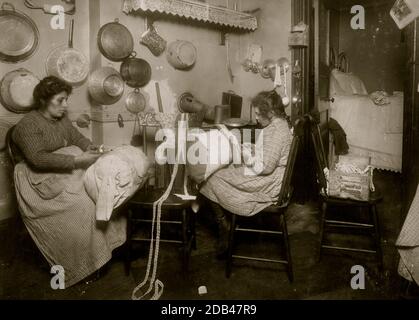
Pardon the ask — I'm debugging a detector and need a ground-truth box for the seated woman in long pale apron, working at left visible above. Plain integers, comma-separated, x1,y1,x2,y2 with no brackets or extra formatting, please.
12,77,126,287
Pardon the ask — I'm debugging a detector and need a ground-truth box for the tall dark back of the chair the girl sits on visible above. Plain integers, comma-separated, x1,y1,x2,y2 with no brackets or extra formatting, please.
278,119,305,205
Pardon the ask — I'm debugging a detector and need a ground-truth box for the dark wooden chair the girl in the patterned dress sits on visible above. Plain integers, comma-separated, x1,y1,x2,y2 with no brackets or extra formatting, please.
226,119,304,282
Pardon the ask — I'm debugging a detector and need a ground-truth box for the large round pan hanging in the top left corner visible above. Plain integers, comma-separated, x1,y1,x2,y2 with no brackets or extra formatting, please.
0,2,39,63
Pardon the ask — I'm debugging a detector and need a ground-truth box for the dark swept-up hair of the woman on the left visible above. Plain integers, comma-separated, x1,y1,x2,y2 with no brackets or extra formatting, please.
33,76,73,109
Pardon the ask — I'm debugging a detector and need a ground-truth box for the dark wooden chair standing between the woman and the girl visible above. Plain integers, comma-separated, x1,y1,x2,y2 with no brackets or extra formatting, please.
125,121,196,275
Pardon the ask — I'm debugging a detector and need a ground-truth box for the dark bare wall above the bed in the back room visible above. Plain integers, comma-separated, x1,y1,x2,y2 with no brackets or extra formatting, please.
339,0,405,93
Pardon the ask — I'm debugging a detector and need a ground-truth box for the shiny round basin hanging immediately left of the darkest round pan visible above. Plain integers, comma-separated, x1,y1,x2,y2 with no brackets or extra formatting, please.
88,67,124,105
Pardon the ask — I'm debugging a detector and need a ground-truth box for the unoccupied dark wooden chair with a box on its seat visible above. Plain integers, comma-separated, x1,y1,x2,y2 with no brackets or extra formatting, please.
307,117,383,270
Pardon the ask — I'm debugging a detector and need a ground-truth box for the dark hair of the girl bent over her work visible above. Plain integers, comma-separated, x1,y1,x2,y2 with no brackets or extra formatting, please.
252,90,290,124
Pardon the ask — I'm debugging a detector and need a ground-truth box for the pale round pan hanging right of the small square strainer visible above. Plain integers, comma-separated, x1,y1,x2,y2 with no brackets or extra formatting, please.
167,40,197,69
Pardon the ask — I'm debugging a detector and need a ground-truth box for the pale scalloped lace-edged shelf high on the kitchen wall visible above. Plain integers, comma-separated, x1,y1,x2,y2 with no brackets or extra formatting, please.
123,0,257,31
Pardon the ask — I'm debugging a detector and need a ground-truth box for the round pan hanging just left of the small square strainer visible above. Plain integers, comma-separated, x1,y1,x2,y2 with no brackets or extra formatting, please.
97,19,134,61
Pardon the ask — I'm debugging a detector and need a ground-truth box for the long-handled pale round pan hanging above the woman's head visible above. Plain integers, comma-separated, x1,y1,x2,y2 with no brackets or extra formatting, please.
46,19,89,86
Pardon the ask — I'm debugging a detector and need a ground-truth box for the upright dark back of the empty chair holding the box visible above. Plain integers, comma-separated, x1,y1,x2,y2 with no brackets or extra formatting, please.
306,116,328,191
